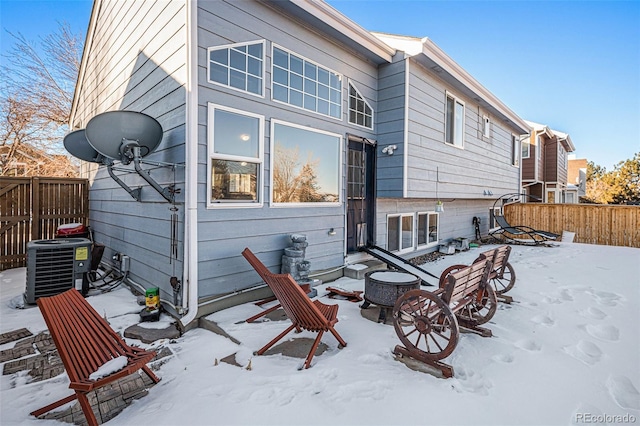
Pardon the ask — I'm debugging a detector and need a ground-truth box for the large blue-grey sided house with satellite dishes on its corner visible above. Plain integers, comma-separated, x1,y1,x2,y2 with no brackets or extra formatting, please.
71,0,530,326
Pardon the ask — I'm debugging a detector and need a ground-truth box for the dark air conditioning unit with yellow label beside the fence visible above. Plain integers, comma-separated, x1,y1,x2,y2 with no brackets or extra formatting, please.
24,238,91,304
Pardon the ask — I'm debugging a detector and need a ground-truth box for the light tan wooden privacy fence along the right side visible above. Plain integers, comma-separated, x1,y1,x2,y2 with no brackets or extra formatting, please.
504,203,640,247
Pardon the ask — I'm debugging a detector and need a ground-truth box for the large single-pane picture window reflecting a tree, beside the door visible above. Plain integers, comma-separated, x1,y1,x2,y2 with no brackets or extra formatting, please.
271,120,342,206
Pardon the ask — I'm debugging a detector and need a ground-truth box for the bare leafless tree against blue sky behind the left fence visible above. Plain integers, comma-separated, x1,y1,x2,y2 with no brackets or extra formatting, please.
0,23,82,174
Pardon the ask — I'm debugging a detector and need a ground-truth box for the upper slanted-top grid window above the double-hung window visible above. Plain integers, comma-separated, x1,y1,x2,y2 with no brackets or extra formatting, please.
208,41,264,96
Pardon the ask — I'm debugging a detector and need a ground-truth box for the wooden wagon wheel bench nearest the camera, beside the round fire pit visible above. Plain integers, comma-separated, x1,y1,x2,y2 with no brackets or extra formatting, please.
393,259,497,377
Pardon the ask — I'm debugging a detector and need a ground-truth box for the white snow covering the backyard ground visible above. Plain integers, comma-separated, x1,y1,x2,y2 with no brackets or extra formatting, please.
0,243,640,425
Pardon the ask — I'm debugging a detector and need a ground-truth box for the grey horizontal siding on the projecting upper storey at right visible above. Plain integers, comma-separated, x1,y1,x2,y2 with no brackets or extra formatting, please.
407,58,520,199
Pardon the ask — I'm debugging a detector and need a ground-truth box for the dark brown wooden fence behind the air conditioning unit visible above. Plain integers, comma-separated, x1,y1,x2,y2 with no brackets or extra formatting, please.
0,177,89,271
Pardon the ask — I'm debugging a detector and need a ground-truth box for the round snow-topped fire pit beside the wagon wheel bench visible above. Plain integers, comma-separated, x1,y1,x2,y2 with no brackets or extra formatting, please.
360,271,420,323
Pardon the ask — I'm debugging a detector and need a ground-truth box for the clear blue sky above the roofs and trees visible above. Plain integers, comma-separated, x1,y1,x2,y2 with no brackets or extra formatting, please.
0,0,640,170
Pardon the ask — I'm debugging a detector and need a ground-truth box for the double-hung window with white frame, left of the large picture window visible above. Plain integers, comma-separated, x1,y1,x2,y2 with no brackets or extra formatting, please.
207,104,264,207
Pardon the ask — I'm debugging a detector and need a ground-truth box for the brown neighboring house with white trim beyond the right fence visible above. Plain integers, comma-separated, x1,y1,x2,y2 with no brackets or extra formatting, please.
522,121,577,203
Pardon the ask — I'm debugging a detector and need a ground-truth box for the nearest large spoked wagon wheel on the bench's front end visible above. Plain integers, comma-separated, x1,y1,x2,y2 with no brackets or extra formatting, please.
393,290,459,361
